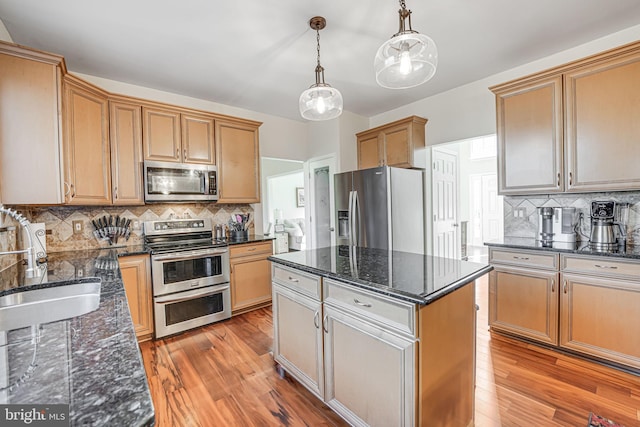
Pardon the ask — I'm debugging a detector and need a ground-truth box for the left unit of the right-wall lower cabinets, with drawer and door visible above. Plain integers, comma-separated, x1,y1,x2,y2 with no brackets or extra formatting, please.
489,248,559,345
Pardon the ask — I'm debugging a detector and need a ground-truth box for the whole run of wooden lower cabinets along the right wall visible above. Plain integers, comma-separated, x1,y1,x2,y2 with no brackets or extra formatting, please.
489,248,640,369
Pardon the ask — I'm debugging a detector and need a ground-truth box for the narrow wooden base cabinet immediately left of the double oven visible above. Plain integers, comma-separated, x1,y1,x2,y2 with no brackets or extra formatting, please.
118,255,154,342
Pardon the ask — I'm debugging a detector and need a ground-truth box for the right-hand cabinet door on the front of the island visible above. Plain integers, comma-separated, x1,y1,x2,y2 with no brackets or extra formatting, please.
323,304,416,427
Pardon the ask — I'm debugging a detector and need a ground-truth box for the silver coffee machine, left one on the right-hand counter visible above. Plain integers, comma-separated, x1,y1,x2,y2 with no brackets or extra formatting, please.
537,206,577,245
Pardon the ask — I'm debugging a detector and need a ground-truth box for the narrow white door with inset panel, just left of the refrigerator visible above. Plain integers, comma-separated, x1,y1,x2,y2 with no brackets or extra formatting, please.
305,155,336,249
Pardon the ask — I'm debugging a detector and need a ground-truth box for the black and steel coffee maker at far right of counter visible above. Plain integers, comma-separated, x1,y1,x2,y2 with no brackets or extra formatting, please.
589,200,628,251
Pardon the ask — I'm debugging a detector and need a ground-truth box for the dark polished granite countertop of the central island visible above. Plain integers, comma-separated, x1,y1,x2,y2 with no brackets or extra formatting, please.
268,246,492,305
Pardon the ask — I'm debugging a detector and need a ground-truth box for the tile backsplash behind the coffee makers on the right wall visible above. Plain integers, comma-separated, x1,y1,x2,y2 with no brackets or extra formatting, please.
504,191,640,245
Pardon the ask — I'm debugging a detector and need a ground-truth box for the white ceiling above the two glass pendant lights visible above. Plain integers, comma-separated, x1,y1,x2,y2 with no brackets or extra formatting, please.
0,0,640,120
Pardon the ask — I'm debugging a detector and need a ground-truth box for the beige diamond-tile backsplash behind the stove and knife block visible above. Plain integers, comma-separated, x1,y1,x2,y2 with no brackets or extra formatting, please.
7,203,253,254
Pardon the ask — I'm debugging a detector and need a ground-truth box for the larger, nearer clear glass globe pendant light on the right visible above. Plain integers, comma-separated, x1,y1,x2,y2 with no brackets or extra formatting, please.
373,0,438,89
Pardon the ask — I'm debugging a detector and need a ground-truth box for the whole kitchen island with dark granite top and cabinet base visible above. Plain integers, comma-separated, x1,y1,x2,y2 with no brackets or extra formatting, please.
269,246,491,426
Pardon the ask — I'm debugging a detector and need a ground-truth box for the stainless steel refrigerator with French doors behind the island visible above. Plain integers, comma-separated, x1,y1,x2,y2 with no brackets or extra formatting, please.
334,166,425,254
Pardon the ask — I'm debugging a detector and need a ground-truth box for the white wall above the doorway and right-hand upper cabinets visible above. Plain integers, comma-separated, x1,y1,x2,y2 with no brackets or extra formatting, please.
371,25,640,145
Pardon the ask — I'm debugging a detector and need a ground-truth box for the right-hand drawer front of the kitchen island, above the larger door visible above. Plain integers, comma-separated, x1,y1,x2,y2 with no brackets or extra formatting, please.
324,279,416,337
